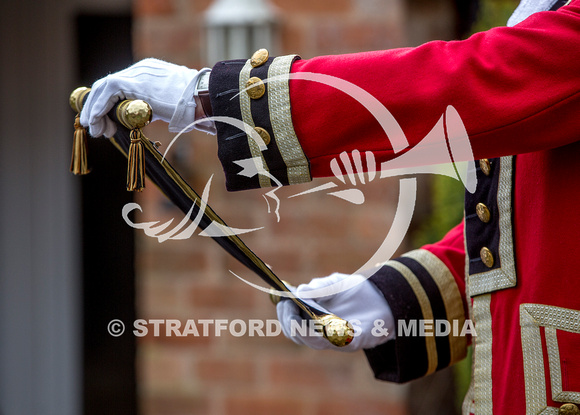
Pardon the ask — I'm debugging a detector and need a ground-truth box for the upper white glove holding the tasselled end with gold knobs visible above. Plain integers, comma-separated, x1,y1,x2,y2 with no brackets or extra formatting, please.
80,58,210,137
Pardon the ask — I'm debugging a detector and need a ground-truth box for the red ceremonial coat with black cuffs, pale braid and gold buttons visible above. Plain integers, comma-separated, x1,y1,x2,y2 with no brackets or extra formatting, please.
210,0,580,414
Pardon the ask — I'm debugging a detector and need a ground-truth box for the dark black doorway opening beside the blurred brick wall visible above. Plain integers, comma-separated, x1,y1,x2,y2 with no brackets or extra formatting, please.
77,15,137,415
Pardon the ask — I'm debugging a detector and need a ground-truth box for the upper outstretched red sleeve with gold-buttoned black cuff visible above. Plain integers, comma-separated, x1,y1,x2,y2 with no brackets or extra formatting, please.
210,0,580,190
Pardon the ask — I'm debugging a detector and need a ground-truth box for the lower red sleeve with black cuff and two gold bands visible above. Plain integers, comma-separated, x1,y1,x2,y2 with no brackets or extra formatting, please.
365,223,470,383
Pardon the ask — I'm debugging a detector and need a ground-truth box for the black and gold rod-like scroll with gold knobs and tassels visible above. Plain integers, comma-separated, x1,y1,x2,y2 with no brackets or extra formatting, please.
69,87,354,347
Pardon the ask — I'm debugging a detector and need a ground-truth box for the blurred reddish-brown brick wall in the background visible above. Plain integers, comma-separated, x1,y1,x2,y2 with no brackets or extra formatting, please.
134,0,458,415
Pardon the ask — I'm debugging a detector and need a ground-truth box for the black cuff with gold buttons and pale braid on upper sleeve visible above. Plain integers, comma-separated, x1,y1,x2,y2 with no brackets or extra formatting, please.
209,55,311,190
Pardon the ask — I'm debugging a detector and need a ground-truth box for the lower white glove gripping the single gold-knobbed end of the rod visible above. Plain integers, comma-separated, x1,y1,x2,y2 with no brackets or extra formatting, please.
276,273,395,352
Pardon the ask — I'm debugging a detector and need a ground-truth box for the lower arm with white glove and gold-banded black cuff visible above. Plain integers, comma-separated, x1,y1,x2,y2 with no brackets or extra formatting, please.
277,224,469,383
